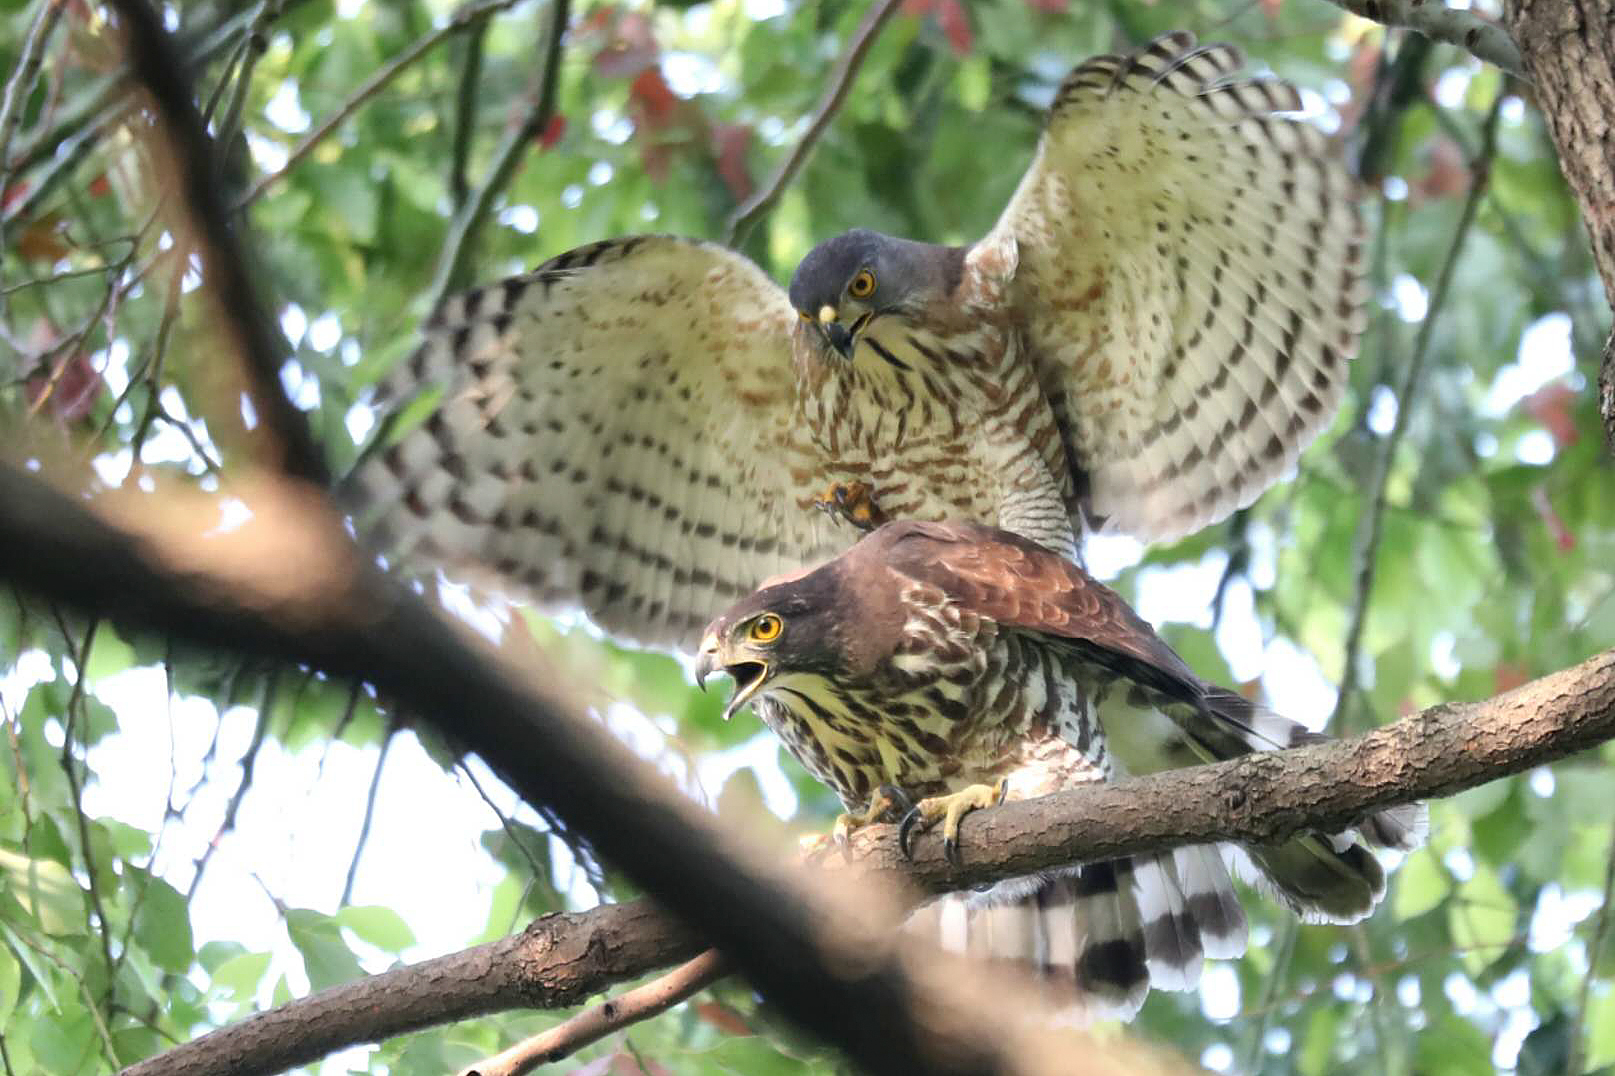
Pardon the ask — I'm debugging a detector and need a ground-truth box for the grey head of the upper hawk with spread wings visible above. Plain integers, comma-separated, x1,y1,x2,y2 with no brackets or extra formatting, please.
790,228,964,359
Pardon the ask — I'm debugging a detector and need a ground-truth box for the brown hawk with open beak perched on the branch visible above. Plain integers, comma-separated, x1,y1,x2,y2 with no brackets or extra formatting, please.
698,522,1426,1016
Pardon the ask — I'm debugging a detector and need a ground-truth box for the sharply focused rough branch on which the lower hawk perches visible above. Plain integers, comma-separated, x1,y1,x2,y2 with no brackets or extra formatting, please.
91,604,1615,1076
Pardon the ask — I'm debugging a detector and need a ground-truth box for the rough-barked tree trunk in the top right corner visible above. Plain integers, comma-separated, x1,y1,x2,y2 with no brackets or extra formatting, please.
1505,0,1615,452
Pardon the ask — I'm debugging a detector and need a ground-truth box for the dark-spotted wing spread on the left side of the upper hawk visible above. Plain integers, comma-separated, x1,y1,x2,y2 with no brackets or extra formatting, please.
352,236,845,645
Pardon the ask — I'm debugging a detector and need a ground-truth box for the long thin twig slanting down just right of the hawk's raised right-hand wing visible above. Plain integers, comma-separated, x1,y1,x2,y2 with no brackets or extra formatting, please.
1328,87,1507,732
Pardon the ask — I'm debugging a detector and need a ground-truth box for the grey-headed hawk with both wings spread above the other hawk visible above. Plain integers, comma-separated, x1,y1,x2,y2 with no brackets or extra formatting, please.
354,34,1363,645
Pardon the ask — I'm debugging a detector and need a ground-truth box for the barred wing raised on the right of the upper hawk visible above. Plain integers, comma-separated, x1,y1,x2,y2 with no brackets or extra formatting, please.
988,34,1363,540
